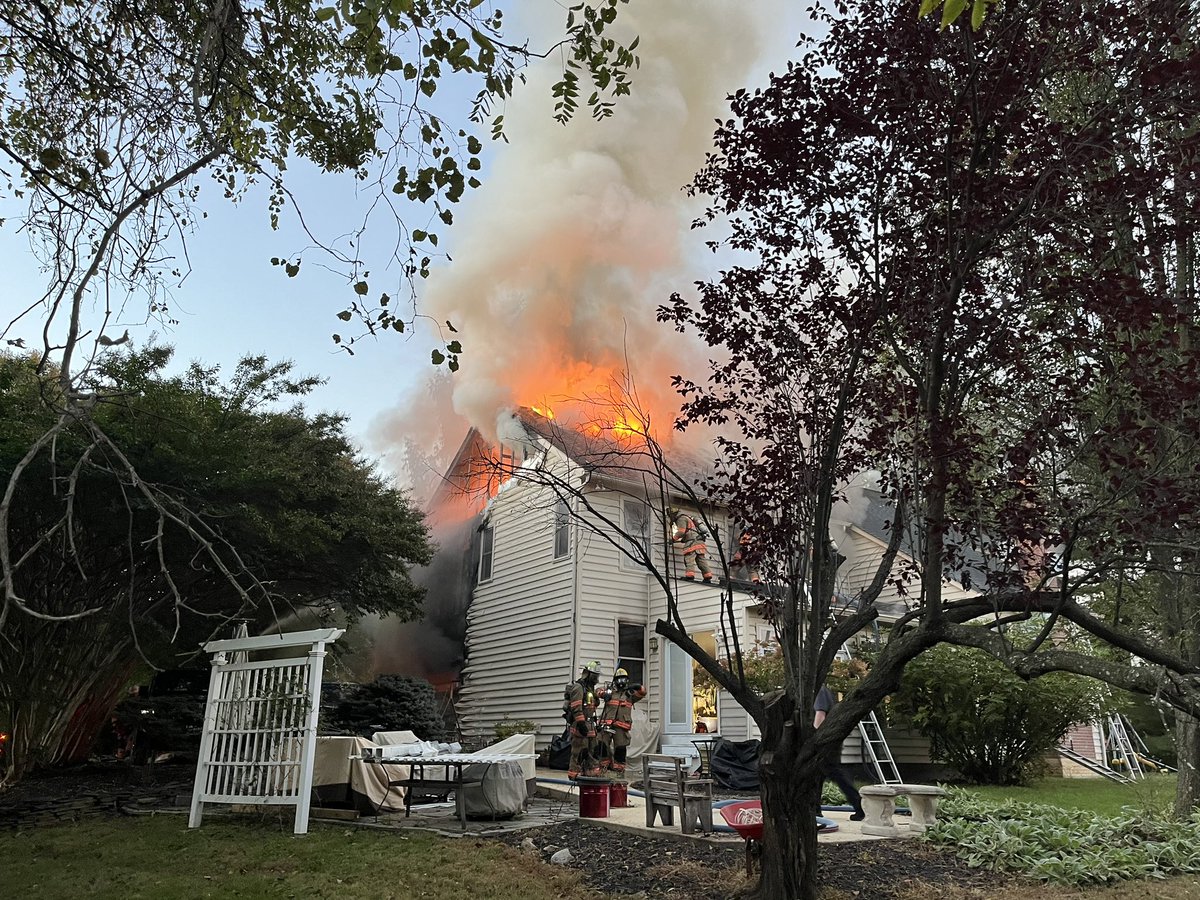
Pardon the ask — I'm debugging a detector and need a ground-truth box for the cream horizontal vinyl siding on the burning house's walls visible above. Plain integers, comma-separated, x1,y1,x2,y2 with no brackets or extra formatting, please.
457,460,919,764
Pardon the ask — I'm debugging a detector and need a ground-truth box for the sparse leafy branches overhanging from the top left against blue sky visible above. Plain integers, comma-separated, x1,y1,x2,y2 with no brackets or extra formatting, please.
0,0,638,362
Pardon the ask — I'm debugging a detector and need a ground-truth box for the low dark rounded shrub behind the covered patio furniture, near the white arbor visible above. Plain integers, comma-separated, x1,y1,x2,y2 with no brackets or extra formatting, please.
325,674,445,740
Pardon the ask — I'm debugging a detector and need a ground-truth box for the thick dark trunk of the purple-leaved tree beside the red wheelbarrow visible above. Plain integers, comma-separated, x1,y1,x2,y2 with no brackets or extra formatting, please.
751,751,824,900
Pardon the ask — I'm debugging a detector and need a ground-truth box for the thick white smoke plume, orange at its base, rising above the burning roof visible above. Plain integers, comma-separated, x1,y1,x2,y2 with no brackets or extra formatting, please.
421,0,796,433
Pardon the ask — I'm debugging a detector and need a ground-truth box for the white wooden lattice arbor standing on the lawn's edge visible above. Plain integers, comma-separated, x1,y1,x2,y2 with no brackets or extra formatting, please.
187,628,344,834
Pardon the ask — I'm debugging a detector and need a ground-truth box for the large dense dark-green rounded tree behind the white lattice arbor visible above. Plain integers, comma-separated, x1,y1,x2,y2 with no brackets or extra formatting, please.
0,347,431,778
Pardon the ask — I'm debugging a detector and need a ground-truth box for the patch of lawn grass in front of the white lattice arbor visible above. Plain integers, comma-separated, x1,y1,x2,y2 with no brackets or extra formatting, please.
0,815,598,900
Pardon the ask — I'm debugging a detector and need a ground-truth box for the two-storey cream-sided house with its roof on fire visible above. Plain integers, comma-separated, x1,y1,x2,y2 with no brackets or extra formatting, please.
442,412,998,772
